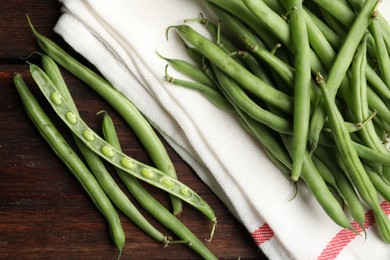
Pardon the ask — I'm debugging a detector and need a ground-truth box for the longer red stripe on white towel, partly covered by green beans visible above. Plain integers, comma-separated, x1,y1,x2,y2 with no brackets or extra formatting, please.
318,201,390,260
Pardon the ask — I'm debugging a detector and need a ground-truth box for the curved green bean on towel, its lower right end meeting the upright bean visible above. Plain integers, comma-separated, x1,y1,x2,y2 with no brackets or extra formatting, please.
213,63,292,134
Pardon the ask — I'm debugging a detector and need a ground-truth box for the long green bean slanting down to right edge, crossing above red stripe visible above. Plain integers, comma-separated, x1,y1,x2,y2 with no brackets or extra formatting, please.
317,74,390,243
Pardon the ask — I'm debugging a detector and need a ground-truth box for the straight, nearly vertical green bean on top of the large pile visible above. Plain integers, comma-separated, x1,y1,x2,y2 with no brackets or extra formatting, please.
282,0,311,181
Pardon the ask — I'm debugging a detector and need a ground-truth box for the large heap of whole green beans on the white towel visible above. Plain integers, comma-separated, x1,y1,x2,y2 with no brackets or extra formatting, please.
159,0,390,243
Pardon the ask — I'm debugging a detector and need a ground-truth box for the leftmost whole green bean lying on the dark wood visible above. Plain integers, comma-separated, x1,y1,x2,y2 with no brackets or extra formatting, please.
14,73,125,256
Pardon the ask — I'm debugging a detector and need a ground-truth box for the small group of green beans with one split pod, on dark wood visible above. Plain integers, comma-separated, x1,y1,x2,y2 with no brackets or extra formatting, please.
14,17,217,259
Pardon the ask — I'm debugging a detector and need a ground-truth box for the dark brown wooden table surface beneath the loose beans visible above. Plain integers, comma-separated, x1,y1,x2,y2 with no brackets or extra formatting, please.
0,0,265,259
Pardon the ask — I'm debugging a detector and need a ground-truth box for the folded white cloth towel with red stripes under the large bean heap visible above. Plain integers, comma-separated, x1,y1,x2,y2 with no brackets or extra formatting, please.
55,0,390,259
